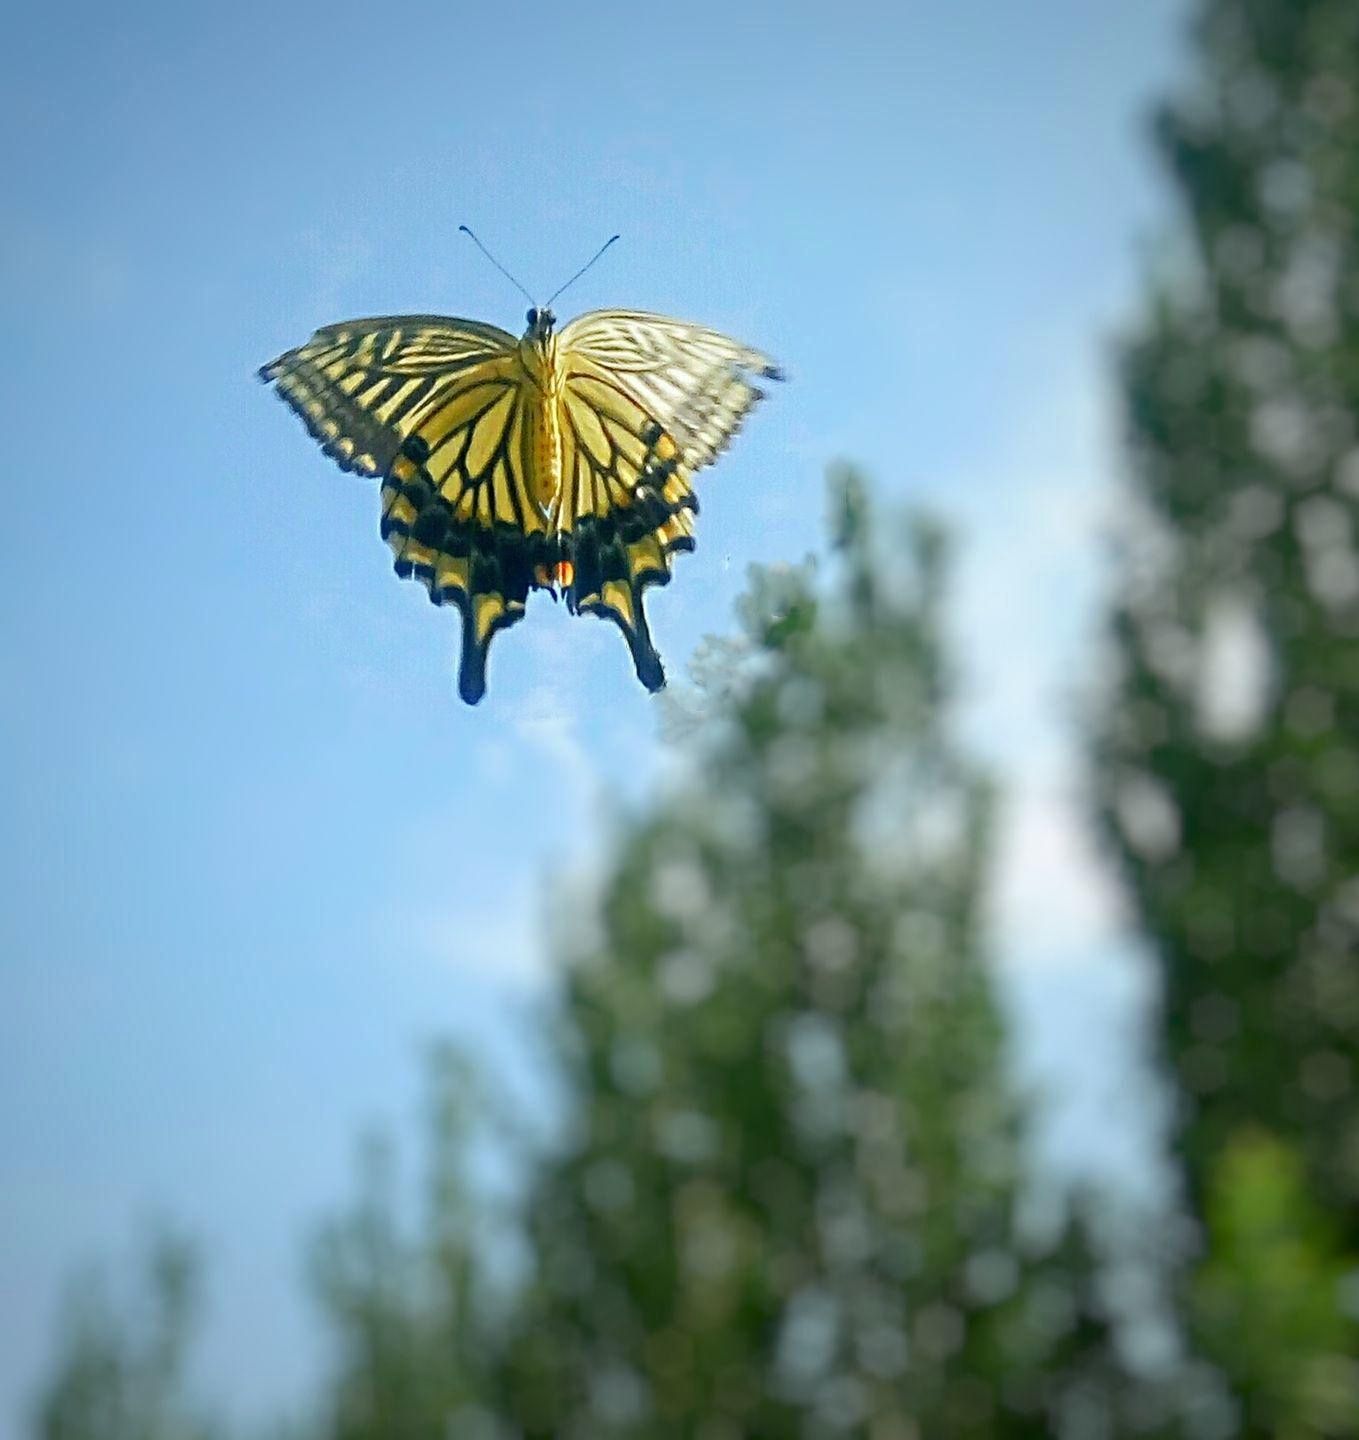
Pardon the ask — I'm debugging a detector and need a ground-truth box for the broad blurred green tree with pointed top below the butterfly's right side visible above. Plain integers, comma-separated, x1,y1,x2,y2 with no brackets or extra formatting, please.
500,475,1156,1440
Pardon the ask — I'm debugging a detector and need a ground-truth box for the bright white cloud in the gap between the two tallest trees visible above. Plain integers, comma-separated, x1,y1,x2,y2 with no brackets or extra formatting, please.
949,340,1124,965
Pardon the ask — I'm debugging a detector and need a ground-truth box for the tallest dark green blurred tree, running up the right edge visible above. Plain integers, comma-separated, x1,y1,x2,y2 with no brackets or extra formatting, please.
1098,0,1359,1436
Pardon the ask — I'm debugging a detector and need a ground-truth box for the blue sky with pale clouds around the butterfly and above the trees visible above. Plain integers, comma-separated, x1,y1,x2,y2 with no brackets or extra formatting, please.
0,0,1183,1436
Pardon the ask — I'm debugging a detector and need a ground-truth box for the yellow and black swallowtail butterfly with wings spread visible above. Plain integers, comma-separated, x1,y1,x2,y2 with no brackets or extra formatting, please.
259,266,783,704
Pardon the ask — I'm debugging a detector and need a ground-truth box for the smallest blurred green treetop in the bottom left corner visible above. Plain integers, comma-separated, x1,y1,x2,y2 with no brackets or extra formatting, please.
33,1233,219,1440
